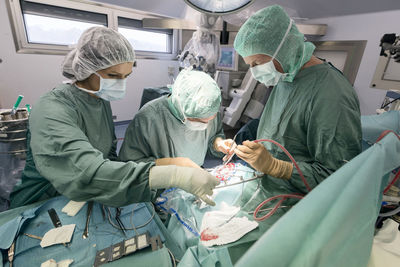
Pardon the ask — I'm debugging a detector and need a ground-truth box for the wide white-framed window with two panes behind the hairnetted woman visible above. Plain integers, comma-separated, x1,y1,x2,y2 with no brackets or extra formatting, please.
7,0,177,59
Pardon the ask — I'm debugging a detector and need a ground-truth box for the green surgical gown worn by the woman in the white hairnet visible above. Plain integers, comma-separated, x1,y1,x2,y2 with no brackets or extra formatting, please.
11,84,155,208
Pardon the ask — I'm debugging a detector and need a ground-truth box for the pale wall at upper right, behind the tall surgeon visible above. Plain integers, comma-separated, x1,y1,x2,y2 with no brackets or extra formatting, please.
307,10,400,115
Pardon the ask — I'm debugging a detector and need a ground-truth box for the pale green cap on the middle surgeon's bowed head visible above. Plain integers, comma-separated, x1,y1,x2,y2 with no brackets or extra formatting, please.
169,69,221,120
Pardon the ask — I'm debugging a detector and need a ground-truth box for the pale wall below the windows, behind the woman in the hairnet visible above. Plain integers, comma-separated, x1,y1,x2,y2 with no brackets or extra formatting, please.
0,1,178,121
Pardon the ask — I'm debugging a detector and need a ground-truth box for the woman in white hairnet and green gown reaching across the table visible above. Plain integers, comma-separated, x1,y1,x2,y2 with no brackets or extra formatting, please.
11,27,218,207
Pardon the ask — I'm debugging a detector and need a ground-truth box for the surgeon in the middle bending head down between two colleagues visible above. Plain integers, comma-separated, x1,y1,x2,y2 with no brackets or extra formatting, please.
119,69,232,167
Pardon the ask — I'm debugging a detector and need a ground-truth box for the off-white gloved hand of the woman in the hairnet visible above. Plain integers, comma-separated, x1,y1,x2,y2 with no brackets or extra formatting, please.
149,165,219,206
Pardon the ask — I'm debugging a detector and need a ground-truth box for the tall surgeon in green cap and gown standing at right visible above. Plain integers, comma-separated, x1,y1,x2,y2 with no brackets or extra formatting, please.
234,5,361,193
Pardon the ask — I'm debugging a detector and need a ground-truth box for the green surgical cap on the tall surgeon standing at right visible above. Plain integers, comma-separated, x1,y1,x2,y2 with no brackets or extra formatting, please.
234,5,315,82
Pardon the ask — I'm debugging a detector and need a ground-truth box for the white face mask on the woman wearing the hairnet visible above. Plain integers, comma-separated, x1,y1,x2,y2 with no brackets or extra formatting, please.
75,72,126,101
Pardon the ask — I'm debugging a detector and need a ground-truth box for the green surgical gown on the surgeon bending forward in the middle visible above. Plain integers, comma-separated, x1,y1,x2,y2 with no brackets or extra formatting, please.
119,96,224,166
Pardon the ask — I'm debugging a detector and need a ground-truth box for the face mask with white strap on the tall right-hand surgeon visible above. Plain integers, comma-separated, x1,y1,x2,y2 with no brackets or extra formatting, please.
250,20,293,86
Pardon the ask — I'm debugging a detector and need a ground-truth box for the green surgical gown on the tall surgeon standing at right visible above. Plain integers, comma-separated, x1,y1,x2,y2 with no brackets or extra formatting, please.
257,63,361,193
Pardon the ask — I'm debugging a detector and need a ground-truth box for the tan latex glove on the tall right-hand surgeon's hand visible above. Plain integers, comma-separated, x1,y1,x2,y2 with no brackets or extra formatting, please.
235,141,293,179
